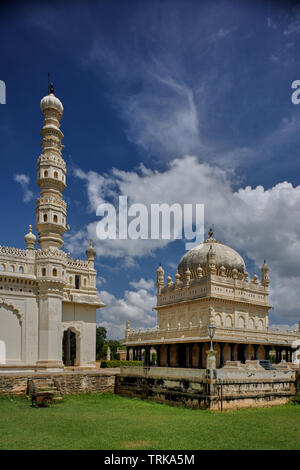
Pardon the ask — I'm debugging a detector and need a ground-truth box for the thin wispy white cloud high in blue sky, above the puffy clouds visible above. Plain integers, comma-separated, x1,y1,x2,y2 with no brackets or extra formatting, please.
121,73,203,157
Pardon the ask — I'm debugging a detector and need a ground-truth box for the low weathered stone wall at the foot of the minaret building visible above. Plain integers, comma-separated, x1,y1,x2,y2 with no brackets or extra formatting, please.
0,372,116,396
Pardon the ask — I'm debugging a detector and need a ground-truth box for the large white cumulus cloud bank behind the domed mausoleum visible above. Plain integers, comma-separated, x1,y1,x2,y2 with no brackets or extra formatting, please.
68,156,300,323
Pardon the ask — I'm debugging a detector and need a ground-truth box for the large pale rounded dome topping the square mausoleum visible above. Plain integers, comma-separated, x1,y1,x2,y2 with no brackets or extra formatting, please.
178,229,246,278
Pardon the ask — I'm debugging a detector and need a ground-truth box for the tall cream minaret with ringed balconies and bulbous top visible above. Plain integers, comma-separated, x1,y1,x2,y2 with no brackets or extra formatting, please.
36,83,66,250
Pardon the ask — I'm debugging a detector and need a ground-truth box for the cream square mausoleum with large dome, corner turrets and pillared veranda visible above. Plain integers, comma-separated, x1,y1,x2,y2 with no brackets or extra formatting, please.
125,230,300,369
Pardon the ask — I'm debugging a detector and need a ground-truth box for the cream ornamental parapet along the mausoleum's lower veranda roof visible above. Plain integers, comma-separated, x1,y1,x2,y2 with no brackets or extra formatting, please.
124,326,299,346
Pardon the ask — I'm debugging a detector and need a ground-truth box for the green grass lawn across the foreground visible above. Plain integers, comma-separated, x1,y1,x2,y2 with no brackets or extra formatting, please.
0,394,300,450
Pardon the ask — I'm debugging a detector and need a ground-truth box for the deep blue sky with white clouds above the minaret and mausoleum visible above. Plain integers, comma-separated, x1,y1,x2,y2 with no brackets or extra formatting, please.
0,0,300,338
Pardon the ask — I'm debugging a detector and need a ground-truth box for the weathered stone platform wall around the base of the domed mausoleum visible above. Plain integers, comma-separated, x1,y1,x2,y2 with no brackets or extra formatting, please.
116,367,296,410
